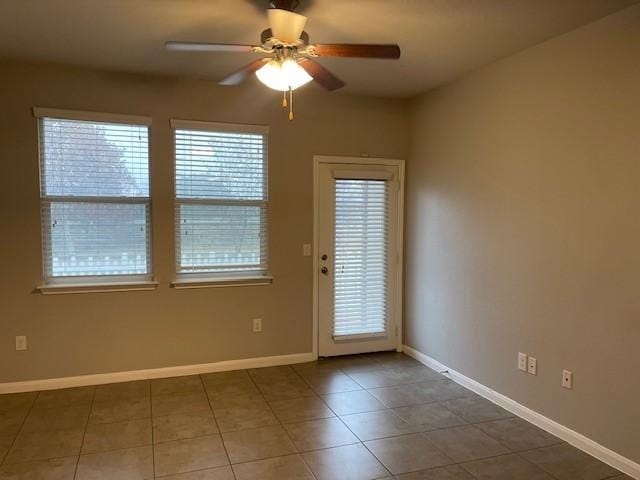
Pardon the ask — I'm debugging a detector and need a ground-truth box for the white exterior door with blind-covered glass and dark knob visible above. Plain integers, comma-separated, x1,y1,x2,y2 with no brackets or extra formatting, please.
316,163,401,356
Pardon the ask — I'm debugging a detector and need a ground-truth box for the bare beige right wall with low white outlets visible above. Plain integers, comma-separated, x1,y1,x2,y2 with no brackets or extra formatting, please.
405,6,640,462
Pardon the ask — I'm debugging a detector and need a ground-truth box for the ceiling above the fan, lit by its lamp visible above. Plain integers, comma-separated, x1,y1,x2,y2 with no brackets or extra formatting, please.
0,0,639,97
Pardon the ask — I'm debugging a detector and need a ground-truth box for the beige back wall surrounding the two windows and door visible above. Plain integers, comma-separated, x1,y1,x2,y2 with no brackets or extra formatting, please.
0,61,409,383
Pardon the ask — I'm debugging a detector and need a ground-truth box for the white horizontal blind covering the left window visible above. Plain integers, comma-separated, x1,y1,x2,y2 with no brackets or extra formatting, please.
39,117,151,283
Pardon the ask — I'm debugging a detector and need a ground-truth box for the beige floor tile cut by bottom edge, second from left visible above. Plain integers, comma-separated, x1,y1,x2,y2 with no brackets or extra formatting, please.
76,446,153,480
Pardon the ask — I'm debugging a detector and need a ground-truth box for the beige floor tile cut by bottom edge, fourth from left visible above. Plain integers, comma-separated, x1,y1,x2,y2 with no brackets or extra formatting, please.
233,455,314,480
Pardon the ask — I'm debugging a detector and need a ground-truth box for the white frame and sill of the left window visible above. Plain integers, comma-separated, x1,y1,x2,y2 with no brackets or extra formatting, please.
33,107,158,294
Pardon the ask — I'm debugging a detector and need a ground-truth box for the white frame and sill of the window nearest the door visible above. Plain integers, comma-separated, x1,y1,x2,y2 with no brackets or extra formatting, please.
170,119,273,289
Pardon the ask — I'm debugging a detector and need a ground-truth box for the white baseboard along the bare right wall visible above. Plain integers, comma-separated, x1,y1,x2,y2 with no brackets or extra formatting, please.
402,345,640,480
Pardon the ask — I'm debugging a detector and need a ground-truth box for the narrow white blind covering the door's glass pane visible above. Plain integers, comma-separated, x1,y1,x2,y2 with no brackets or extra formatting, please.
333,179,389,337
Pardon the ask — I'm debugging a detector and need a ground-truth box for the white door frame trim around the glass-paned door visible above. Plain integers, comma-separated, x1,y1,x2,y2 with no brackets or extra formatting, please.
313,155,405,359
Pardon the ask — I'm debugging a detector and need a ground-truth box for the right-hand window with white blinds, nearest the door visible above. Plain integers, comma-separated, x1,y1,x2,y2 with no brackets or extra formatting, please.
172,120,268,279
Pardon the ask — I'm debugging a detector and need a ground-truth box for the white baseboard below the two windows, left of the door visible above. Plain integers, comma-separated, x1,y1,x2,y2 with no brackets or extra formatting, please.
0,353,316,394
